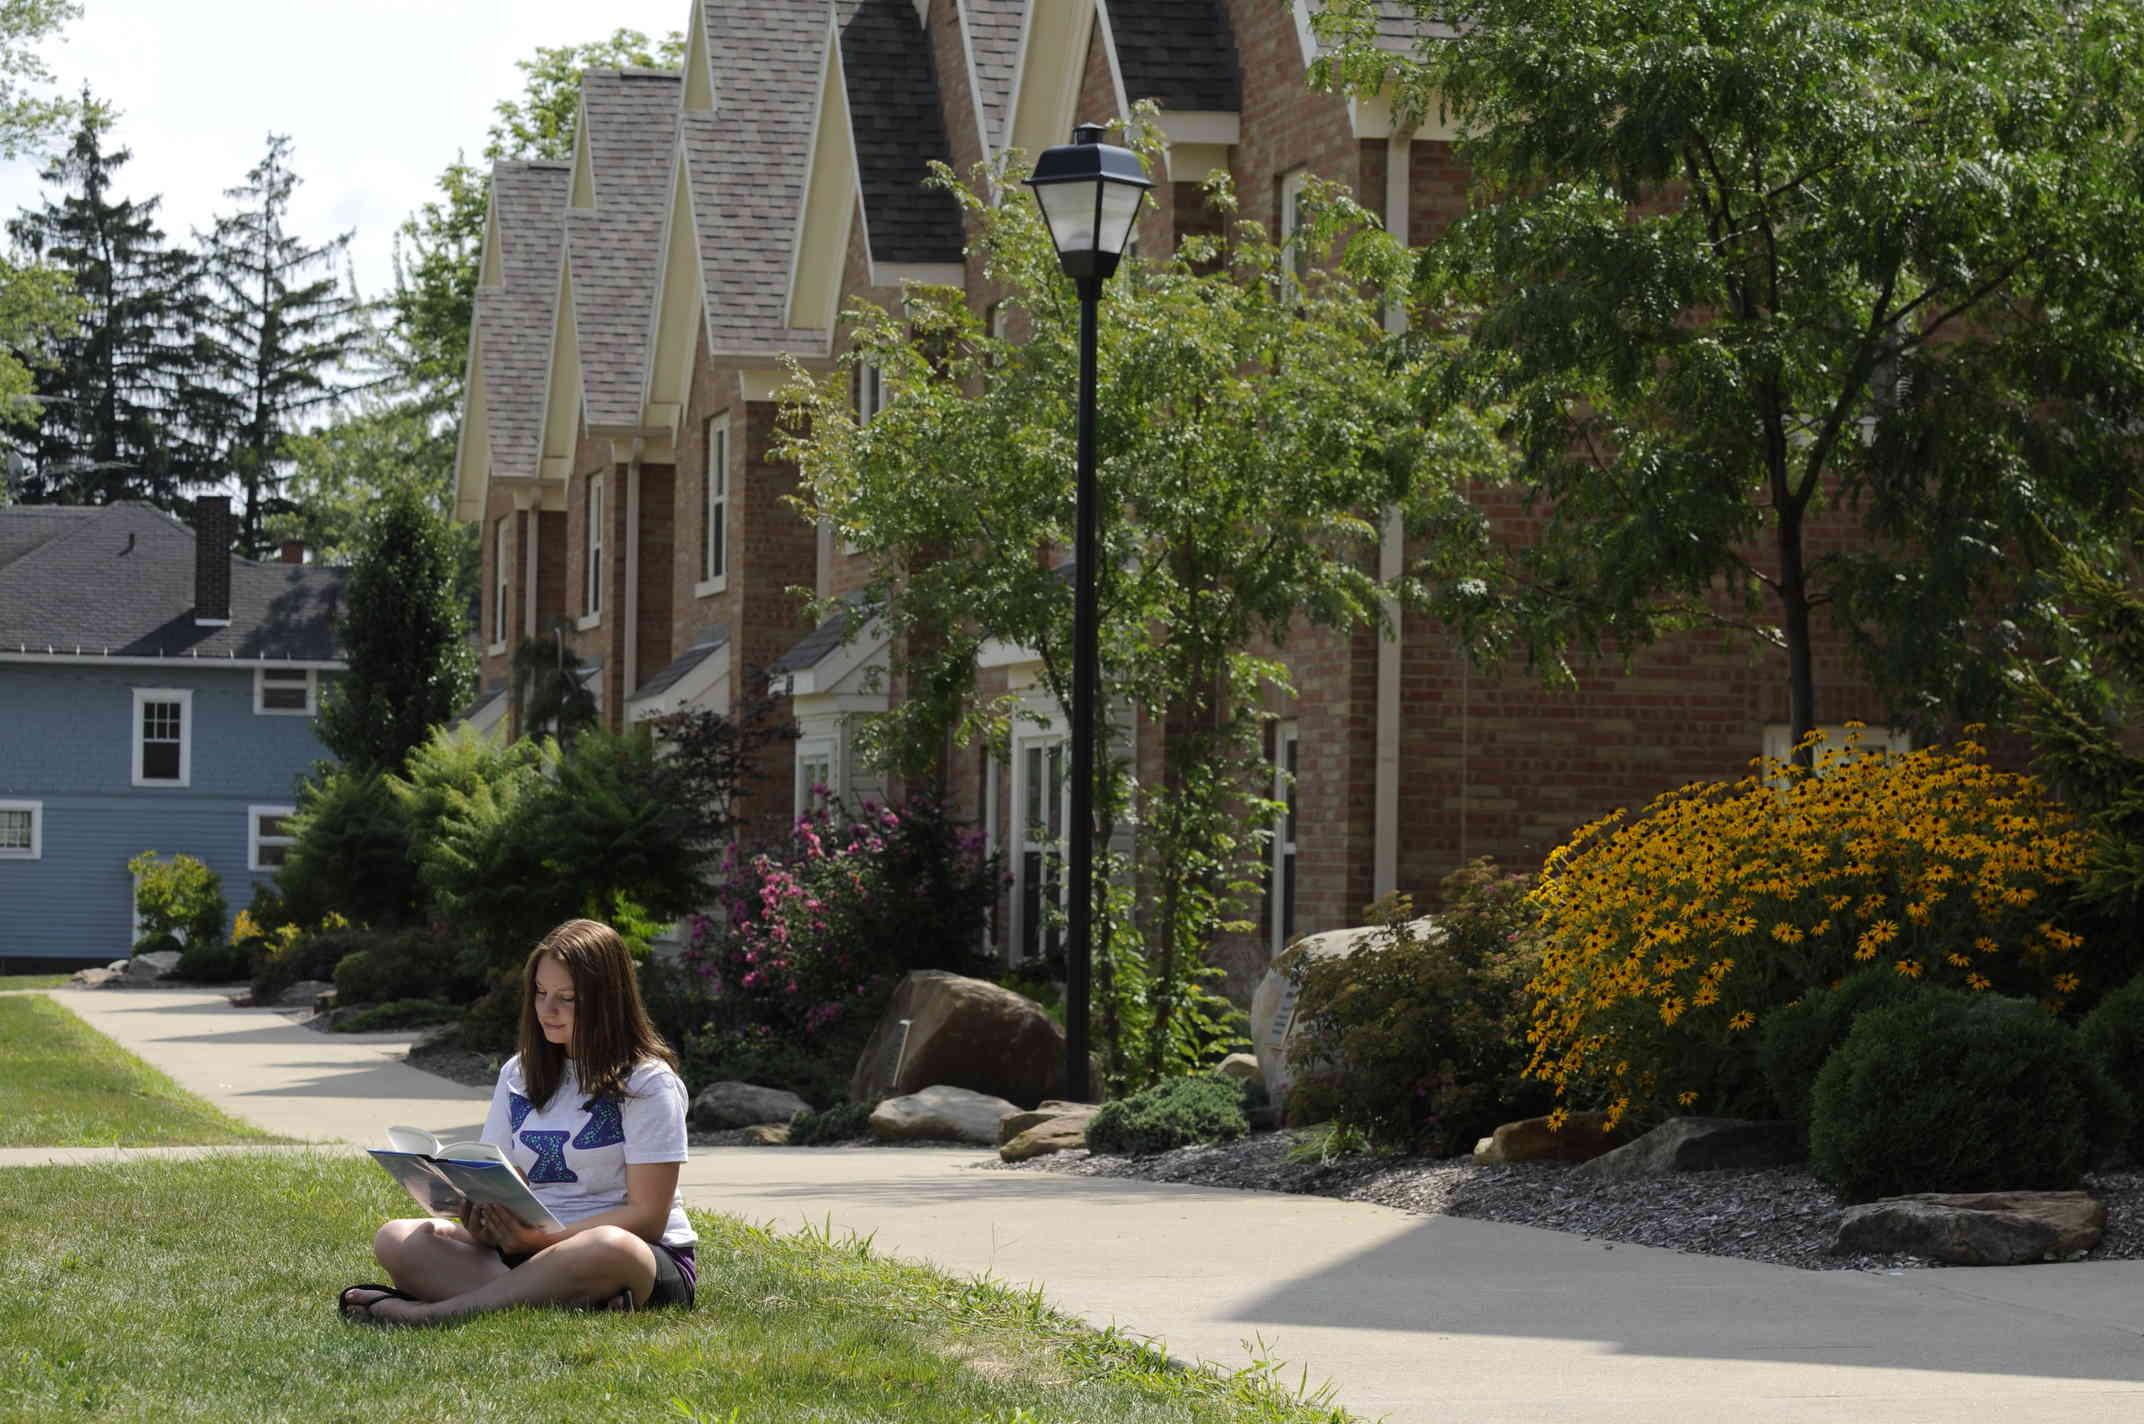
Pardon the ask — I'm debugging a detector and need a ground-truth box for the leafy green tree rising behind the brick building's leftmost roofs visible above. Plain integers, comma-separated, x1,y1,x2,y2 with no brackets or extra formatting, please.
388,28,684,412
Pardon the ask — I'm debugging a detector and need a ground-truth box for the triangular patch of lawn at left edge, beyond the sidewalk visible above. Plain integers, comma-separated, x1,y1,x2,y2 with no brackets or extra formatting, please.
0,993,285,1147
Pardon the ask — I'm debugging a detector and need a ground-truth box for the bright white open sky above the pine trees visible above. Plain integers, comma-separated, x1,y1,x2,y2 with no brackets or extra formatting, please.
0,0,693,298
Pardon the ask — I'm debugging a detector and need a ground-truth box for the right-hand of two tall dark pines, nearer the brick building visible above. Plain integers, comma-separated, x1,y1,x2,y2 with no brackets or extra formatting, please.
191,133,371,555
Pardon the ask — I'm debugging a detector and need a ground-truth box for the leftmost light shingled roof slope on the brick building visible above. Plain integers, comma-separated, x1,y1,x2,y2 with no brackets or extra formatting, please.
476,161,572,476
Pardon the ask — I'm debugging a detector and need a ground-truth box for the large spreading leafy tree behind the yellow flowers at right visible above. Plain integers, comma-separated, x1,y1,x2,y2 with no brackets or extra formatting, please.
1312,0,2144,754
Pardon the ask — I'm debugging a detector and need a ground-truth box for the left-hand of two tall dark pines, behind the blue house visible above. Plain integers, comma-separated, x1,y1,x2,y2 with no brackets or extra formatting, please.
9,88,208,508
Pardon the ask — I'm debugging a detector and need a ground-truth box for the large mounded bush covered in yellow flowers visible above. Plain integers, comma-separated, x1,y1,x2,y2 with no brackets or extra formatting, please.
1527,723,2084,1124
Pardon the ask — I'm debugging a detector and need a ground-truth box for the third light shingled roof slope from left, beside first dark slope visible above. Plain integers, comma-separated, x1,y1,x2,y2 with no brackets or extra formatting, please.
680,0,832,354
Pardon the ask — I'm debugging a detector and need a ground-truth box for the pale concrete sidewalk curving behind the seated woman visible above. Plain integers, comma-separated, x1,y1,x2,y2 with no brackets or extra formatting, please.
25,991,2144,1424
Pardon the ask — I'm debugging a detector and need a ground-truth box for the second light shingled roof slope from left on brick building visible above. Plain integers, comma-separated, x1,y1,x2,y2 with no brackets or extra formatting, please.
566,69,680,425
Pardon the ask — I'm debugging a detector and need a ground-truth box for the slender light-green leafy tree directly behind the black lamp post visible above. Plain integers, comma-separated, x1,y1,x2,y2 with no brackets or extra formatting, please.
780,131,1486,1085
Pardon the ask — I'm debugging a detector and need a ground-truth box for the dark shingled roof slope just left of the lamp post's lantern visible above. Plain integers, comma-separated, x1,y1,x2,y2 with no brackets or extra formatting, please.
838,0,963,262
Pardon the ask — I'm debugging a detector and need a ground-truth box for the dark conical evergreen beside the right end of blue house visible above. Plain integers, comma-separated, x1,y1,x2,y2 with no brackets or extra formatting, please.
319,487,476,772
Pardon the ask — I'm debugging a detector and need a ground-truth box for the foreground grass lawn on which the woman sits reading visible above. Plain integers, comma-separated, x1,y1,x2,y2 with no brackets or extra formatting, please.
0,1154,1346,1424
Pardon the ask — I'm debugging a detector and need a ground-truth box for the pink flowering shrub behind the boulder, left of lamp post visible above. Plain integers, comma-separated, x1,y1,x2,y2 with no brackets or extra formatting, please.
684,800,1001,1042
